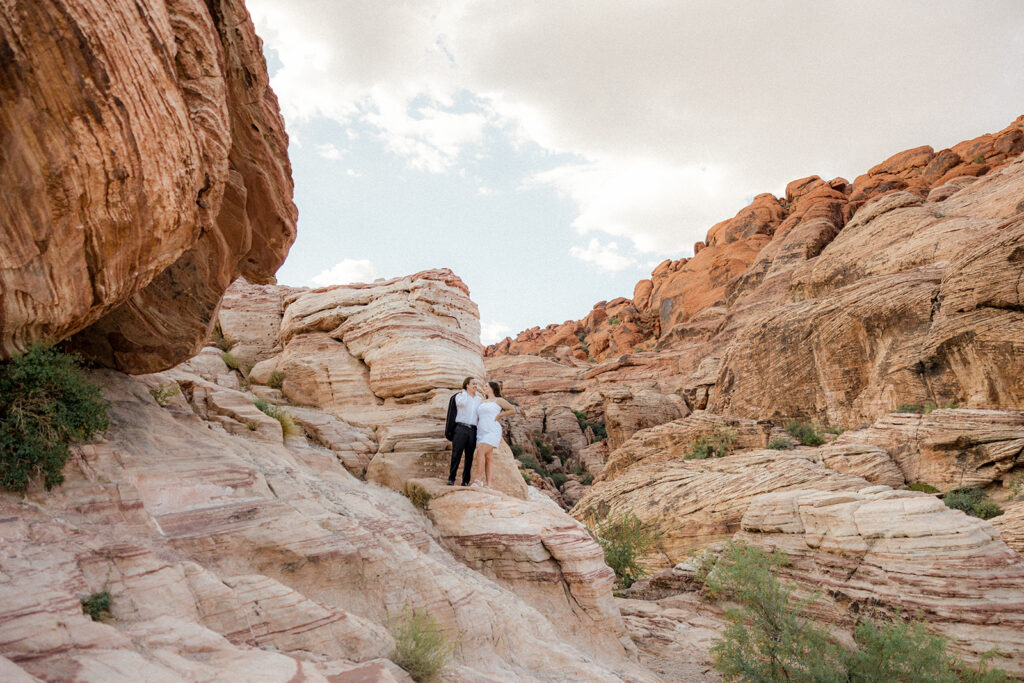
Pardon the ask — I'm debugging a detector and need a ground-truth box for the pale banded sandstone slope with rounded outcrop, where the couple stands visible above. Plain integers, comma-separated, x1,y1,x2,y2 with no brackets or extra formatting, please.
0,270,656,682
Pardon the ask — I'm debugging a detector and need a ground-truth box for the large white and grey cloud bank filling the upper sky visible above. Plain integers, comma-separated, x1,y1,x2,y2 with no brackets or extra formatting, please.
248,0,1024,256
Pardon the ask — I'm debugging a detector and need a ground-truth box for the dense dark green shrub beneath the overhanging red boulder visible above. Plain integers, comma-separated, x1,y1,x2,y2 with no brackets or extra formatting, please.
0,344,110,492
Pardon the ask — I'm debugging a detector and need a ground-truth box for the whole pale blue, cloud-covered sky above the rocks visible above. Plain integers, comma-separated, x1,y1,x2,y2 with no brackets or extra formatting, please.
247,0,1024,344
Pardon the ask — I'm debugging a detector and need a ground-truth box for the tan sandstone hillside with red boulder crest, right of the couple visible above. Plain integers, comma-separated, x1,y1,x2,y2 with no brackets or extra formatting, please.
486,117,1024,426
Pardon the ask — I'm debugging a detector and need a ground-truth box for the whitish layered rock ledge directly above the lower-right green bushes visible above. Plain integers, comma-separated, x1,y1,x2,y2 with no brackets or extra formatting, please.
736,486,1024,676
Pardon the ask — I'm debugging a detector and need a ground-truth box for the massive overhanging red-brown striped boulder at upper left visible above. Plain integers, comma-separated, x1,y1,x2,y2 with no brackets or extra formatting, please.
0,0,297,373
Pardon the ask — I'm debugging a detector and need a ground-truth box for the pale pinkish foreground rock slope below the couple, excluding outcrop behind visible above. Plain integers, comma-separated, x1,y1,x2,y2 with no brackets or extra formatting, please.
0,370,652,681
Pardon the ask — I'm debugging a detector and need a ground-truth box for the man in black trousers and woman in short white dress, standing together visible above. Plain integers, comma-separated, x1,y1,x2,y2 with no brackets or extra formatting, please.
444,377,515,488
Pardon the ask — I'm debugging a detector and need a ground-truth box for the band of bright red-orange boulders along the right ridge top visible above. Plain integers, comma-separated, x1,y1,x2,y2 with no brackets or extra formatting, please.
486,117,1024,378
